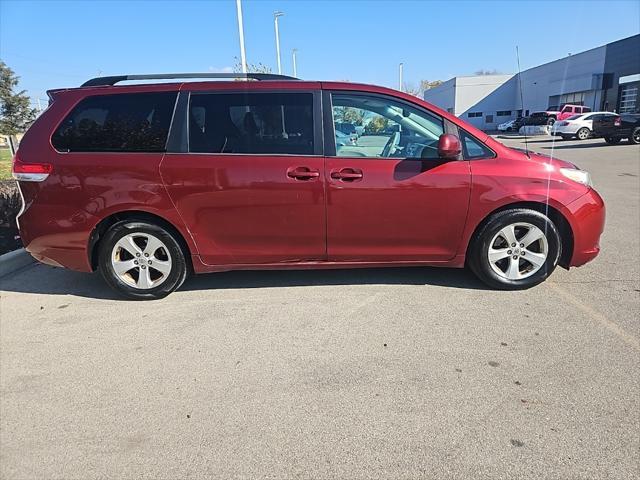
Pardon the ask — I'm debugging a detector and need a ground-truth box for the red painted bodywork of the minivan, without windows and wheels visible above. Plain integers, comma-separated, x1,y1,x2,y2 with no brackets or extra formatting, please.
16,81,604,278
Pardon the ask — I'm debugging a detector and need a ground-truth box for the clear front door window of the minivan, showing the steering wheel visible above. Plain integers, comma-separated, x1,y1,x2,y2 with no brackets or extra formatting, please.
332,93,444,158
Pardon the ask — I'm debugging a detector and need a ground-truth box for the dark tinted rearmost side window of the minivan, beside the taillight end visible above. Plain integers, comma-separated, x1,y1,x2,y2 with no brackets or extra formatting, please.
51,92,177,152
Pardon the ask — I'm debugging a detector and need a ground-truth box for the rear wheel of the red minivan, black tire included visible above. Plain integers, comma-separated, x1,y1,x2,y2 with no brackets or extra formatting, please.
98,220,188,300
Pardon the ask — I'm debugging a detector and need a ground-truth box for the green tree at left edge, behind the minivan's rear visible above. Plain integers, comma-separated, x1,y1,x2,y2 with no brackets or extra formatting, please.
0,60,36,135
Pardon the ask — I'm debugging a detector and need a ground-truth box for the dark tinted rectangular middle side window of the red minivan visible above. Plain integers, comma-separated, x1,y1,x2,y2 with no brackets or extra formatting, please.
189,93,314,155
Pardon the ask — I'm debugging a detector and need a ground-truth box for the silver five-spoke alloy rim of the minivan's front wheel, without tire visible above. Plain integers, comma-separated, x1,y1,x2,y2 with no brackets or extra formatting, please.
487,223,549,280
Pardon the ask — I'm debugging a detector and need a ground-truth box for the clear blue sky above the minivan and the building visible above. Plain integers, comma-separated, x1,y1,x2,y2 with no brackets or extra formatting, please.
0,0,640,104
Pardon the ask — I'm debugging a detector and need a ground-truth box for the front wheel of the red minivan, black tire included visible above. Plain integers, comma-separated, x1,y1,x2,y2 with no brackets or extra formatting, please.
467,208,562,290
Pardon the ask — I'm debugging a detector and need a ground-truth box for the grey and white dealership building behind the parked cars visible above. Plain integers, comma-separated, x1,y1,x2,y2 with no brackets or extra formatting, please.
424,35,640,130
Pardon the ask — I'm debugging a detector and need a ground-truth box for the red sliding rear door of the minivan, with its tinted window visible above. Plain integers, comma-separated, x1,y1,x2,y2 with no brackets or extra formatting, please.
161,89,326,265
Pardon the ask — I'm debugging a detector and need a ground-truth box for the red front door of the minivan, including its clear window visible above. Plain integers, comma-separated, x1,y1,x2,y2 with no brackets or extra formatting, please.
324,91,471,262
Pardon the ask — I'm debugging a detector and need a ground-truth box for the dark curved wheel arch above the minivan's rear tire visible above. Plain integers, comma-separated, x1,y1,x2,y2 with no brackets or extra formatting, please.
87,210,193,271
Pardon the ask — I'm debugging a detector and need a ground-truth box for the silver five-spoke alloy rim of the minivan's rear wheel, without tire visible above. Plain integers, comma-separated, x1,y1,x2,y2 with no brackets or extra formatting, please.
111,232,172,290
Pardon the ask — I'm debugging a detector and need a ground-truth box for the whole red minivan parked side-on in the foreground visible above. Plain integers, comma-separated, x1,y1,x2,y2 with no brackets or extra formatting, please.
13,74,605,299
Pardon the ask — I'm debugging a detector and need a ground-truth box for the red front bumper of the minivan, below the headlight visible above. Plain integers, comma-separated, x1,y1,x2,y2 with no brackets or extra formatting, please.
567,188,605,267
